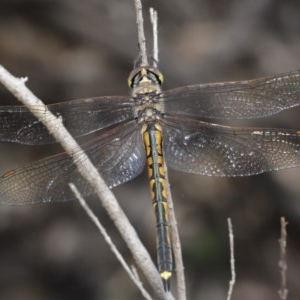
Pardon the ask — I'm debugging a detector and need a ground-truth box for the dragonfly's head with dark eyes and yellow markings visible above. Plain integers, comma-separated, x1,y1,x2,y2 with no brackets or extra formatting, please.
128,66,163,94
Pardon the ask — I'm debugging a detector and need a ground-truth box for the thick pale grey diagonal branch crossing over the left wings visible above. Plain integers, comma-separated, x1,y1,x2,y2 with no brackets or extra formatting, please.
0,65,172,299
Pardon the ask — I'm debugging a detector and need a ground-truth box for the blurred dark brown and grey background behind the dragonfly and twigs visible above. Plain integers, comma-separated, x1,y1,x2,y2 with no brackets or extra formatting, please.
0,0,300,300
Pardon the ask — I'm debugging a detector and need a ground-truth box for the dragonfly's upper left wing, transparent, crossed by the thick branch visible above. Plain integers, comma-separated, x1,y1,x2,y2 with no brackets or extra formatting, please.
0,96,133,145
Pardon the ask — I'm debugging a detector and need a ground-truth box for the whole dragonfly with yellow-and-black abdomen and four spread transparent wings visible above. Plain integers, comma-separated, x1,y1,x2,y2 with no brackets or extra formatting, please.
0,21,300,291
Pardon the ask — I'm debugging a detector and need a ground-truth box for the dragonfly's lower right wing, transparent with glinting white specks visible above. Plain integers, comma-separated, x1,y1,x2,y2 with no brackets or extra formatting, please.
163,117,300,176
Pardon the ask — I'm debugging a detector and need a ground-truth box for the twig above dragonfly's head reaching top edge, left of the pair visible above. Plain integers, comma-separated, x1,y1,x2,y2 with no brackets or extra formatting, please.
134,0,148,66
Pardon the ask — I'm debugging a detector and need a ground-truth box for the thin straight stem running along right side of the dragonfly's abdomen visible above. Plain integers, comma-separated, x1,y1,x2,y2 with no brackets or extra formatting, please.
165,164,186,300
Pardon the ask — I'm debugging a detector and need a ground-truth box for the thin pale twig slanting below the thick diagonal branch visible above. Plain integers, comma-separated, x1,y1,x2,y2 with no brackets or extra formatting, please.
69,183,153,300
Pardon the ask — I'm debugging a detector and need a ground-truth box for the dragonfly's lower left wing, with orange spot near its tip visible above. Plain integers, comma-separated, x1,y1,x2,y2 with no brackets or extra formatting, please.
0,121,145,204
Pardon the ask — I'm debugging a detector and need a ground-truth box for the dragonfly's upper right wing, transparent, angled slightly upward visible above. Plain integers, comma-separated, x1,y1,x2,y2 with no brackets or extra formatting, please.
160,71,300,119
